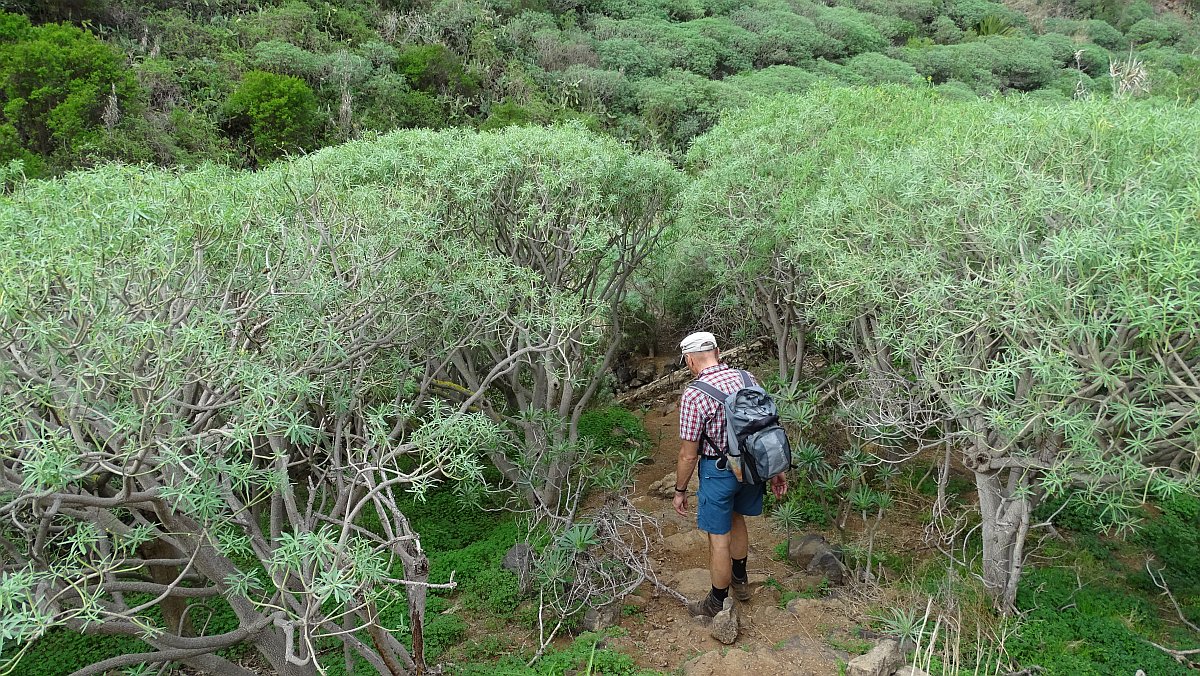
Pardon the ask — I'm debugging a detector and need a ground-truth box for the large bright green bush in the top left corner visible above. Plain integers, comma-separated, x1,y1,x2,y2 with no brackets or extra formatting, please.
0,12,143,171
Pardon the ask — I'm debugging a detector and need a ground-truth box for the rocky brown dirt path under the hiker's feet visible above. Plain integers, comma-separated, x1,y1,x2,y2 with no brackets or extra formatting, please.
604,393,857,676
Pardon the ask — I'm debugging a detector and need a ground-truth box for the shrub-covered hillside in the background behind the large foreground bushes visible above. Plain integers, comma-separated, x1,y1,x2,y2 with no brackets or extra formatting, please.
0,0,1200,175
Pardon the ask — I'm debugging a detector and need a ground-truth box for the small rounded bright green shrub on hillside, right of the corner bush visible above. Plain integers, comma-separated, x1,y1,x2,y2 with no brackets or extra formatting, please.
226,71,322,161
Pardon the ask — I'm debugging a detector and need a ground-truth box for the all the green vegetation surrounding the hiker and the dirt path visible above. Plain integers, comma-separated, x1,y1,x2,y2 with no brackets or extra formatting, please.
0,0,1200,675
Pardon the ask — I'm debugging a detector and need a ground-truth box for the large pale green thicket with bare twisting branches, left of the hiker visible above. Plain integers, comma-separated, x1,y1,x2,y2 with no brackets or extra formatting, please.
0,128,680,674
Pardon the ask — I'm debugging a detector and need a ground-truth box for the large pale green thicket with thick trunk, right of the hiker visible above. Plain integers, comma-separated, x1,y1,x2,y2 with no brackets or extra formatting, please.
685,89,1200,608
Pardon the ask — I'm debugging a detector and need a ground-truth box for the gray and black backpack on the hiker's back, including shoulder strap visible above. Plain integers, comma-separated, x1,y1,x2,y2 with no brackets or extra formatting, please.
688,371,792,484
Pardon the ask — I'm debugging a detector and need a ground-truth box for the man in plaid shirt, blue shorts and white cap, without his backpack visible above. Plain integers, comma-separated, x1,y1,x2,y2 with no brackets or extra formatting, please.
674,331,787,617
